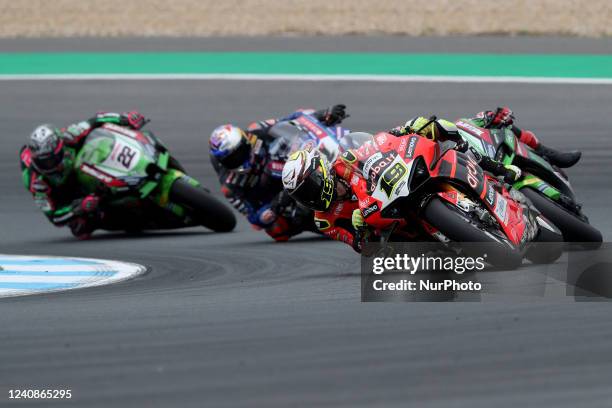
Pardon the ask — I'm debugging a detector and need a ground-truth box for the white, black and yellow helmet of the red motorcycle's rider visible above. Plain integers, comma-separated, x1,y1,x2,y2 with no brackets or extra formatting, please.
282,149,335,211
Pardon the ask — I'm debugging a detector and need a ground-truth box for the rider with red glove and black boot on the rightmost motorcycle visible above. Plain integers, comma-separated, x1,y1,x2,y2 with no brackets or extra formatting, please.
462,106,582,168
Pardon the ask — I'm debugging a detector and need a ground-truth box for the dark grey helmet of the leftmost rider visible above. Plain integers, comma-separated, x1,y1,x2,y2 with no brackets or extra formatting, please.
28,124,64,175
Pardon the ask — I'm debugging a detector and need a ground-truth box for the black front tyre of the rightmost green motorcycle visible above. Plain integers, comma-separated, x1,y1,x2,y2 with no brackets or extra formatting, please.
521,188,603,249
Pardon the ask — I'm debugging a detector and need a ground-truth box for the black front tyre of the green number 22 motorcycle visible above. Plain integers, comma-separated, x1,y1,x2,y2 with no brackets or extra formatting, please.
170,179,236,232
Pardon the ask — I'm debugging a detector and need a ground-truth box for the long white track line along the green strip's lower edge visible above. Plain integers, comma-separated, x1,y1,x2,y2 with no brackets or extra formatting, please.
0,74,612,85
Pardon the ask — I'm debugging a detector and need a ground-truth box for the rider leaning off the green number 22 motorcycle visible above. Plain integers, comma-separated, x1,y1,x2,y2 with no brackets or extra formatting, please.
19,111,146,239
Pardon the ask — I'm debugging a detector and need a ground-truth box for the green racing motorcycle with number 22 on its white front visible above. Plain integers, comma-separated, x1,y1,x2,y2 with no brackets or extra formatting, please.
75,124,236,232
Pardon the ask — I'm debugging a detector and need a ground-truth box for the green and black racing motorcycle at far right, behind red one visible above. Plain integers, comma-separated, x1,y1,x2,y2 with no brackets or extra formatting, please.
456,120,602,243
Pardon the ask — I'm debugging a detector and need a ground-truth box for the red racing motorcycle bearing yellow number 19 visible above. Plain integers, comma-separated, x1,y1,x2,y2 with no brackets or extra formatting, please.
343,133,562,267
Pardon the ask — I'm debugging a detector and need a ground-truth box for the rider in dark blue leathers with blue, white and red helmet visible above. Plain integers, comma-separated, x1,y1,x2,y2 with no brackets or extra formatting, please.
209,104,346,241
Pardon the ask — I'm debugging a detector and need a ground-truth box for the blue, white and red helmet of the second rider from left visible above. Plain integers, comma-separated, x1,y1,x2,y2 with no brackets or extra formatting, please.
209,125,251,169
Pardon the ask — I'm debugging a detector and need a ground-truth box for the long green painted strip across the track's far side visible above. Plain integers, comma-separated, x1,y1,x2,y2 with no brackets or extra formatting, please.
0,52,612,78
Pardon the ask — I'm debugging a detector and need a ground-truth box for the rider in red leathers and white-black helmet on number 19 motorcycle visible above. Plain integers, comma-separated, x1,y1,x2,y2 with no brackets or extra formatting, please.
282,117,521,252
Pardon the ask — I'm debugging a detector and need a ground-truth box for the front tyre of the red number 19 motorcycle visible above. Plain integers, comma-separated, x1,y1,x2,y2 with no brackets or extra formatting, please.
423,196,523,269
